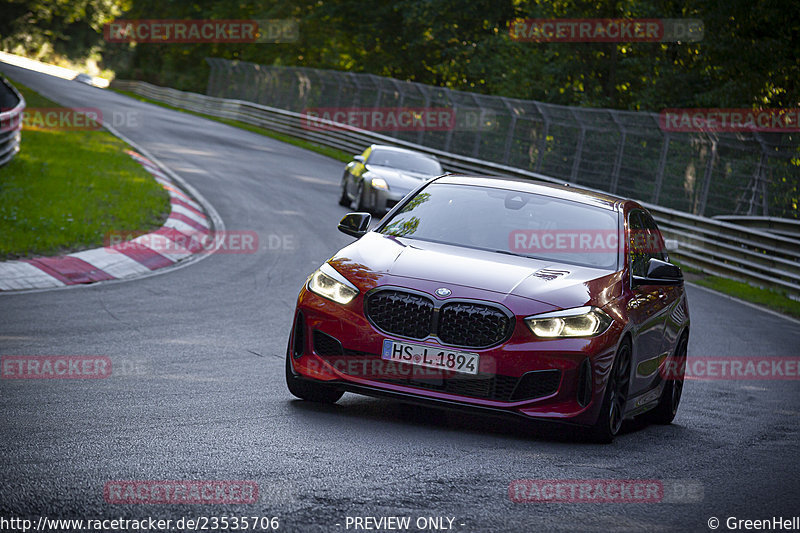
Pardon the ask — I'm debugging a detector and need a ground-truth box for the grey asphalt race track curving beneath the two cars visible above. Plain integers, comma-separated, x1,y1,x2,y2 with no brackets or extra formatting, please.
0,64,800,532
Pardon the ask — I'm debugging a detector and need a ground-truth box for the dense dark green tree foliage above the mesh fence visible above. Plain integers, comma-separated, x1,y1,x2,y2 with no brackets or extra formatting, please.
0,0,800,110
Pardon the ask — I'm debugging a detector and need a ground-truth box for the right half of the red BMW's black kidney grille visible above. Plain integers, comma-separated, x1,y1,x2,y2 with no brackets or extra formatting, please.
438,302,510,348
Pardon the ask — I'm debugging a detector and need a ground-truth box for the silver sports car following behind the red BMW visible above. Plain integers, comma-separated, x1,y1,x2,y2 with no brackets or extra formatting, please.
339,144,444,215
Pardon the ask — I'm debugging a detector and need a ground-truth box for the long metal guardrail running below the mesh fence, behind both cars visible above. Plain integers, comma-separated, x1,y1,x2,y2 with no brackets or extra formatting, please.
112,80,800,299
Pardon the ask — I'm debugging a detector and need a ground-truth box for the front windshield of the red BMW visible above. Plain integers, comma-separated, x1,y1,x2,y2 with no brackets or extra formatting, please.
380,183,619,270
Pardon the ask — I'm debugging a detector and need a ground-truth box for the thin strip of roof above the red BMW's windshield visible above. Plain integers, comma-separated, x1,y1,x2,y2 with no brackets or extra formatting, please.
435,174,624,209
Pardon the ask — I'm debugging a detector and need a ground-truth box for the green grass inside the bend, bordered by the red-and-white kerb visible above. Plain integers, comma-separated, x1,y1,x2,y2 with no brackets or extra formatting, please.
0,79,170,259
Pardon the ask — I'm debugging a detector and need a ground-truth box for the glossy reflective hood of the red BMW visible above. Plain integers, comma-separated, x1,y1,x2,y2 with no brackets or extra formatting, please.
329,232,622,309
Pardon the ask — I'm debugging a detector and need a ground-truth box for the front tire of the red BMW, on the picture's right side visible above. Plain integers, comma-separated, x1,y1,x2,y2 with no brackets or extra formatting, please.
590,339,631,444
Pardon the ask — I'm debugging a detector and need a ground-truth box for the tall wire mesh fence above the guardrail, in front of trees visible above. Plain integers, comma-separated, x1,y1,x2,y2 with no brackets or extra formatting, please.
206,58,800,218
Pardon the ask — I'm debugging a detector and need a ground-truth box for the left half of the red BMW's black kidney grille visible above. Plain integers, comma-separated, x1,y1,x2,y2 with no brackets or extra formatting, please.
366,291,433,339
